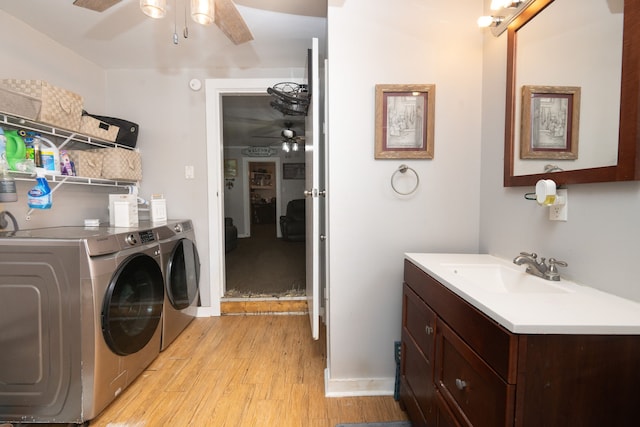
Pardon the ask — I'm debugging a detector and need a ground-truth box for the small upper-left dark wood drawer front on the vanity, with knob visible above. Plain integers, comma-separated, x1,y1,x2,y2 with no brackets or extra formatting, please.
402,284,436,364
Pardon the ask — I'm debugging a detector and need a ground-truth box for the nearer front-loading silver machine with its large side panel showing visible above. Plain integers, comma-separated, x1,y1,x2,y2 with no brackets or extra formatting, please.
0,227,164,424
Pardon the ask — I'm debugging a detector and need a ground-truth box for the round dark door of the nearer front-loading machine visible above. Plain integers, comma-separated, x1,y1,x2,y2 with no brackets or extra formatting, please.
102,253,164,356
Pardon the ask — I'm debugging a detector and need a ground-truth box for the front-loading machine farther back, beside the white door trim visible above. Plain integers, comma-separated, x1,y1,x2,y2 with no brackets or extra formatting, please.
156,220,200,351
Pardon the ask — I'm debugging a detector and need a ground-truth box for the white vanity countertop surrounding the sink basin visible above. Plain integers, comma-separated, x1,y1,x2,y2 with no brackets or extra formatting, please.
405,253,640,335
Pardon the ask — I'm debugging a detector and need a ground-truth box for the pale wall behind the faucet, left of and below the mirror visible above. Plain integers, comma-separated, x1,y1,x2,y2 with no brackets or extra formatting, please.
480,10,640,301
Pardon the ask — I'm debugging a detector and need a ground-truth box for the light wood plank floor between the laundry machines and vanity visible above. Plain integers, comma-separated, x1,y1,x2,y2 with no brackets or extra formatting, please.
90,315,407,427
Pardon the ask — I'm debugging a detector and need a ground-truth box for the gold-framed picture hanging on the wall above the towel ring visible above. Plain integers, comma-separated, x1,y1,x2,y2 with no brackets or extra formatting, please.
375,84,436,159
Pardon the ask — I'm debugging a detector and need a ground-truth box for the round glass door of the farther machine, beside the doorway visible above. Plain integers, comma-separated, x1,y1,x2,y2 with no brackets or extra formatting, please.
167,239,200,310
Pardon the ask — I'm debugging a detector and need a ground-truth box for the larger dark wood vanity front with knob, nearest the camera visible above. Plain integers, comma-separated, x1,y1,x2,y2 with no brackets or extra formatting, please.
435,322,515,427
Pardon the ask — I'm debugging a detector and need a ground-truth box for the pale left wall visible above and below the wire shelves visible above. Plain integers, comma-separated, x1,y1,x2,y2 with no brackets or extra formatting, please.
0,11,122,229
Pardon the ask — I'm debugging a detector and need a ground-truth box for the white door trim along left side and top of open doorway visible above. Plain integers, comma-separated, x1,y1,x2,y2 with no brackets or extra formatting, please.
206,77,302,316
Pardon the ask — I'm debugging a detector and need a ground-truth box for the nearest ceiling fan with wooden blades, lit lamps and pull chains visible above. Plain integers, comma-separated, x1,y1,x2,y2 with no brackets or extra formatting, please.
73,0,253,44
